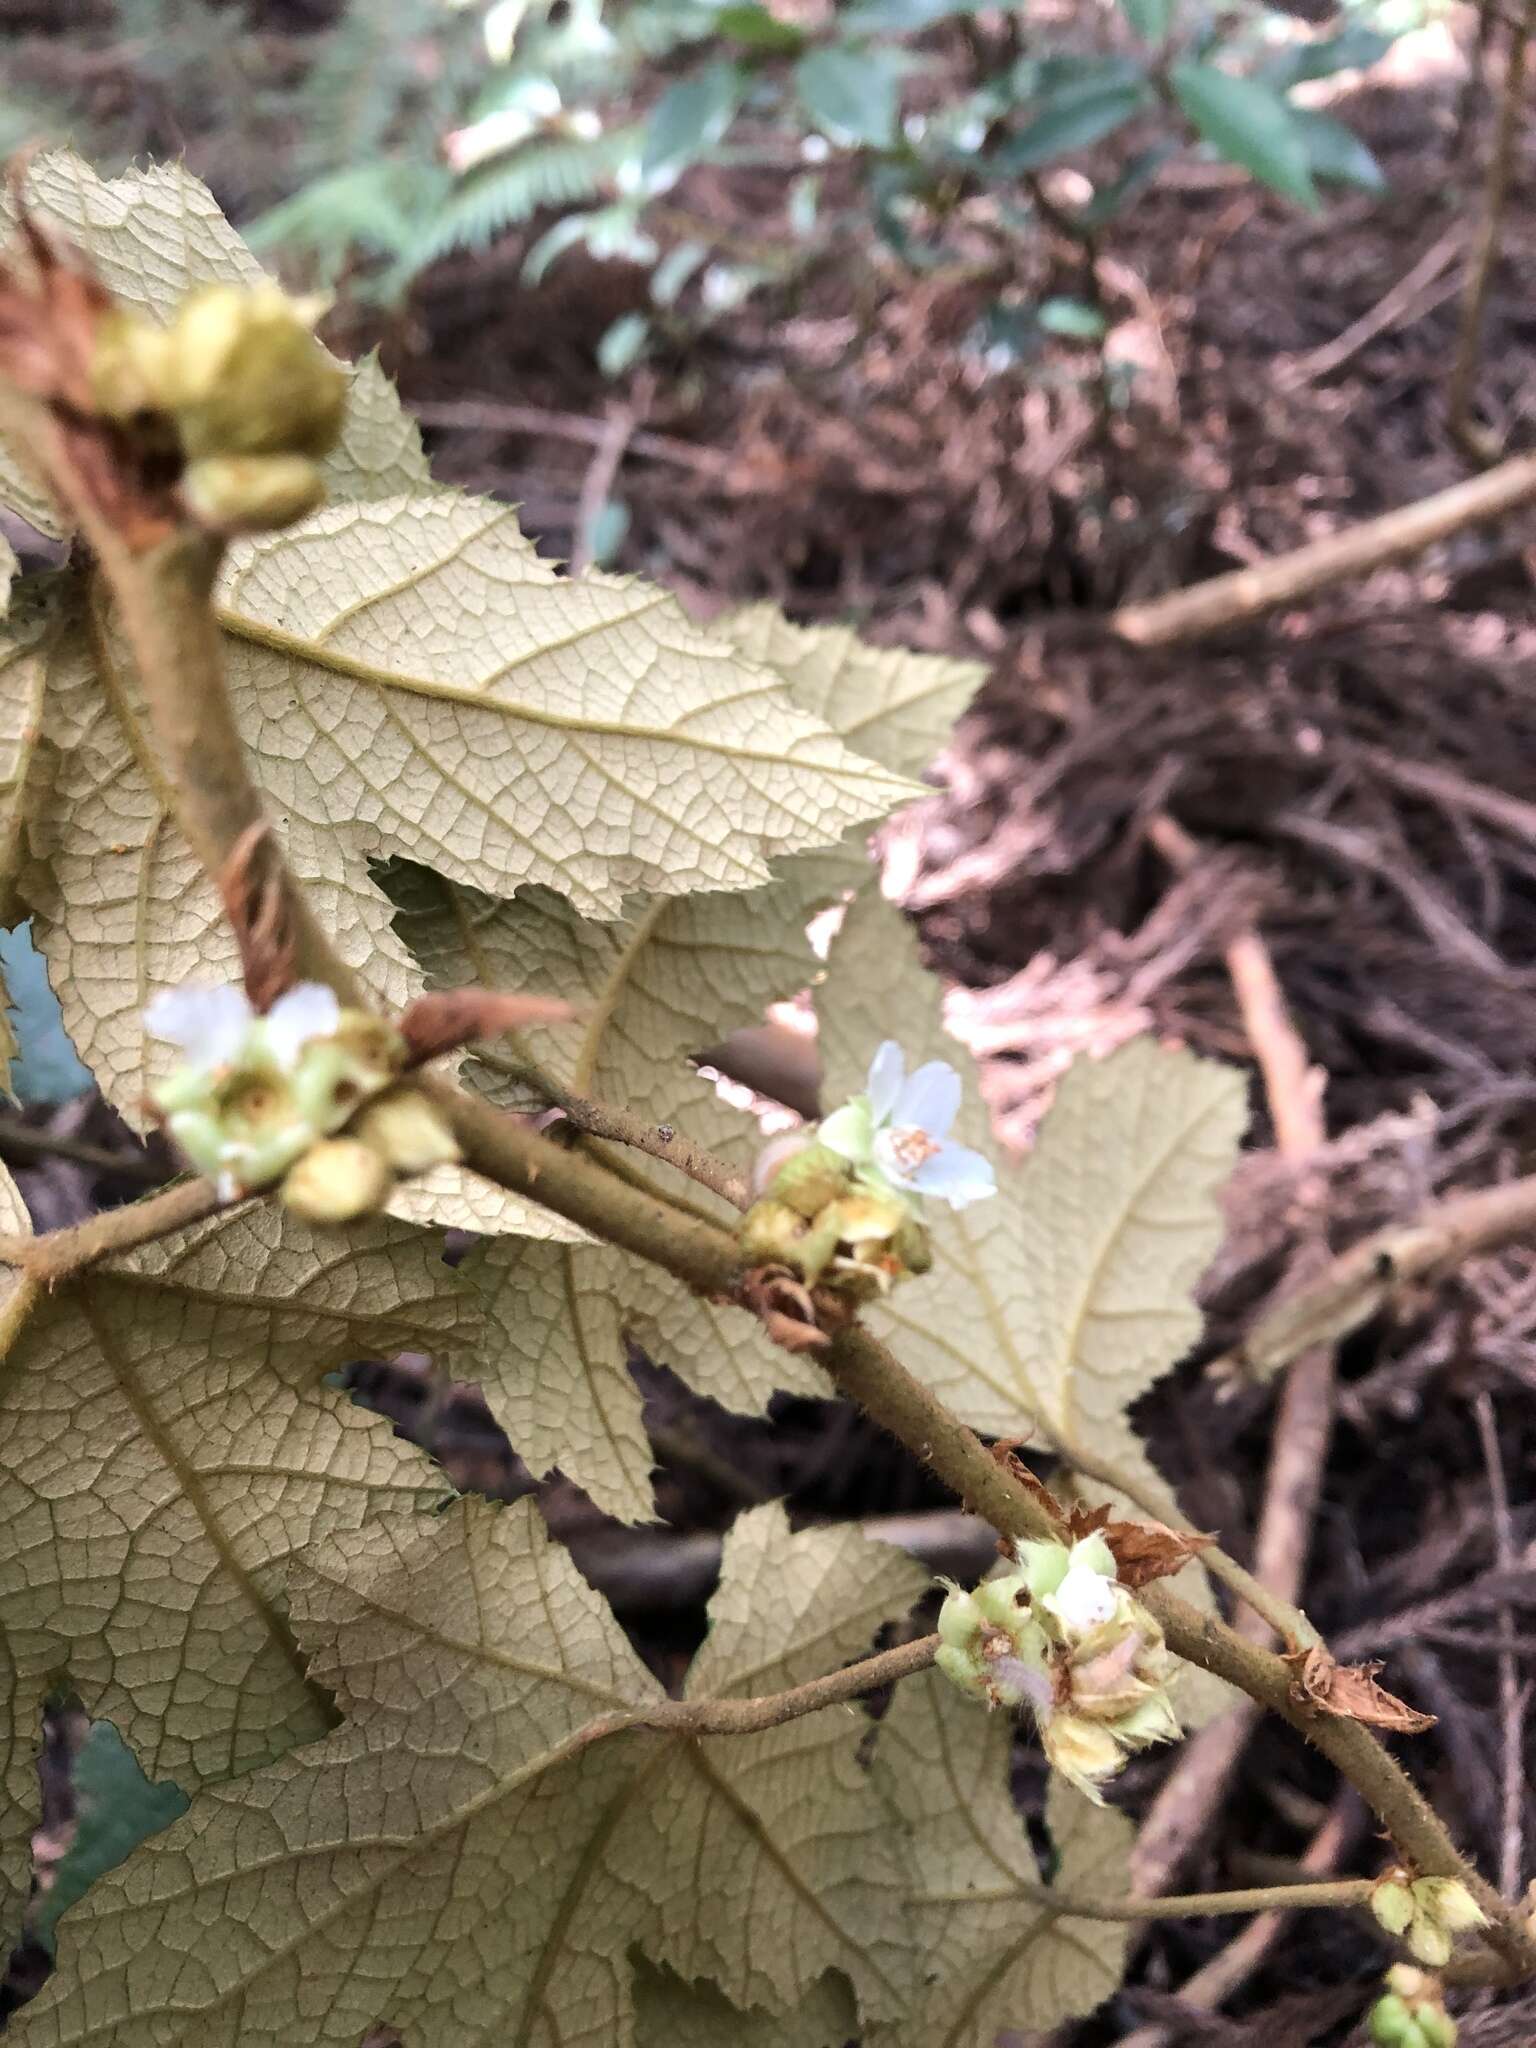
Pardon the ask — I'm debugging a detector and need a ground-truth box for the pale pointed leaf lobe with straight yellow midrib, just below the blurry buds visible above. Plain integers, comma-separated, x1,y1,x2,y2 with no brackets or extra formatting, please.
217,492,907,915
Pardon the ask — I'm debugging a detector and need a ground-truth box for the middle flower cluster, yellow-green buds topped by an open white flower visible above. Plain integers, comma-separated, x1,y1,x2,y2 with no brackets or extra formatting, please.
741,1040,997,1298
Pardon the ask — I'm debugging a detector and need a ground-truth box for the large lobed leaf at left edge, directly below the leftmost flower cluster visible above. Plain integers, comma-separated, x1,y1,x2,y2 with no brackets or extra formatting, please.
0,1208,473,1957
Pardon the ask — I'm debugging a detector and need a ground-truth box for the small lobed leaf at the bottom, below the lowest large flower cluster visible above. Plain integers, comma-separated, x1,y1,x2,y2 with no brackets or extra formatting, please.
868,1673,1133,2048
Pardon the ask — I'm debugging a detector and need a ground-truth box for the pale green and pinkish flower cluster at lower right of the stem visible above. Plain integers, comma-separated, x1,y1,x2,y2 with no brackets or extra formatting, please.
936,1536,1182,1804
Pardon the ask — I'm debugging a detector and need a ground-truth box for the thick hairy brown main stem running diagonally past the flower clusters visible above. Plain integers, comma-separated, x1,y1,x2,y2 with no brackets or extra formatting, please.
33,419,1536,1974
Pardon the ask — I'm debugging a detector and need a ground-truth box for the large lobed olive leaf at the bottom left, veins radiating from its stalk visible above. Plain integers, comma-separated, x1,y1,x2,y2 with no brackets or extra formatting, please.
27,1503,922,2048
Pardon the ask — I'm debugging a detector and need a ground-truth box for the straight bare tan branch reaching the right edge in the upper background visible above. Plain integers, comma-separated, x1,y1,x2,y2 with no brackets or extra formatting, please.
1110,455,1536,647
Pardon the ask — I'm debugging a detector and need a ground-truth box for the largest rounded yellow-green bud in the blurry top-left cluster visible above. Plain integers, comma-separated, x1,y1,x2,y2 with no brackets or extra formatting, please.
166,285,346,459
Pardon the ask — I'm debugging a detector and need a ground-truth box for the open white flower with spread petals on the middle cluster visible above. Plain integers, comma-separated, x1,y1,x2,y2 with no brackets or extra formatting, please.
821,1038,997,1208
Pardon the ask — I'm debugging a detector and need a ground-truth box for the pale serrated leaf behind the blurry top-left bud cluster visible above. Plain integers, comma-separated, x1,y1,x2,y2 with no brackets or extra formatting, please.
0,150,430,537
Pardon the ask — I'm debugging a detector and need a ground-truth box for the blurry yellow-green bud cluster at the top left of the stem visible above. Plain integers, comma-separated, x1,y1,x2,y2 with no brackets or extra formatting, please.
90,283,346,532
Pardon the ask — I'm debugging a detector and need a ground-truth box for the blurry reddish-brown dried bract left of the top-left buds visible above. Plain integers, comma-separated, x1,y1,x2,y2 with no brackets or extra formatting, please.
0,154,180,553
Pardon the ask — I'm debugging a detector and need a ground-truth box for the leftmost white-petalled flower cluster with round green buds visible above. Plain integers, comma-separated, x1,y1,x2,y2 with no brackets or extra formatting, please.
143,981,459,1223
